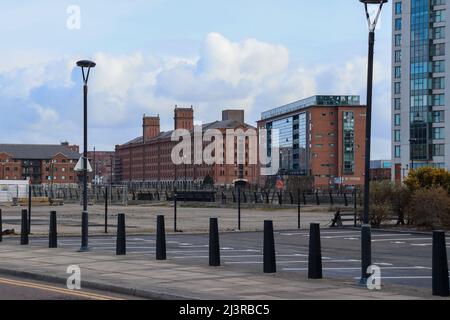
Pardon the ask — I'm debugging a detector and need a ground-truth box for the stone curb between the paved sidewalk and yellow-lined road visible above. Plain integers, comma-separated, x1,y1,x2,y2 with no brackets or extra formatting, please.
0,268,200,300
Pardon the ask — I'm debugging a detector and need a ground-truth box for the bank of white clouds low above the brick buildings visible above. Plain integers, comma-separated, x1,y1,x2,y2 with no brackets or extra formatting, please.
0,33,390,159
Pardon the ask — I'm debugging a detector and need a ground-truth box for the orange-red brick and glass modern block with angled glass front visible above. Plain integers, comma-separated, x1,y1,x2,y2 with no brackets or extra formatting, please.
258,96,366,189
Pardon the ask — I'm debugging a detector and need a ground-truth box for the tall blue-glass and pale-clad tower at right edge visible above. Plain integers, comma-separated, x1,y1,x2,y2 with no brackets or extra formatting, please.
392,0,450,180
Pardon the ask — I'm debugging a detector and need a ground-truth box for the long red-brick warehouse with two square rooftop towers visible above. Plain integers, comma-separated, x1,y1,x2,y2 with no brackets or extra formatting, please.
115,106,259,186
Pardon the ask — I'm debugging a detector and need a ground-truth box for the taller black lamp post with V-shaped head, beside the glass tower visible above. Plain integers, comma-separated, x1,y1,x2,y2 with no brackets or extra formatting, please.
359,0,388,284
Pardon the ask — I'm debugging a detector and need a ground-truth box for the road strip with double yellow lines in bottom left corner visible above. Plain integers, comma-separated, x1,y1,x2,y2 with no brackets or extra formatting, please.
0,275,136,300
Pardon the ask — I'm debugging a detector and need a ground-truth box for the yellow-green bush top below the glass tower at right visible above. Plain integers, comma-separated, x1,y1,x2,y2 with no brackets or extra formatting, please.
405,167,450,193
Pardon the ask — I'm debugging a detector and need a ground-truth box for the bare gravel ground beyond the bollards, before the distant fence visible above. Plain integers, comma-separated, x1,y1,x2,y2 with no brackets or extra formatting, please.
0,203,333,235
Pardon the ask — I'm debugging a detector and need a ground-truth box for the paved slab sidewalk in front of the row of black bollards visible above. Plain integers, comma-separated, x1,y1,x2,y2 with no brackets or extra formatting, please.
0,239,440,300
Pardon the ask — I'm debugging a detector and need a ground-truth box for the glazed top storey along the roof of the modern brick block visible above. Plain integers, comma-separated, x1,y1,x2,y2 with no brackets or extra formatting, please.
261,96,360,120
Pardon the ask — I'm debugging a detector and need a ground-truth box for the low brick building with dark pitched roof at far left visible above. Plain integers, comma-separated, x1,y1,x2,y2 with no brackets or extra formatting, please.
0,142,80,184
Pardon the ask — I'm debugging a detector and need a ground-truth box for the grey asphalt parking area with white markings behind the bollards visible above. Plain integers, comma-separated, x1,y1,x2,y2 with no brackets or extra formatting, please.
1,229,450,288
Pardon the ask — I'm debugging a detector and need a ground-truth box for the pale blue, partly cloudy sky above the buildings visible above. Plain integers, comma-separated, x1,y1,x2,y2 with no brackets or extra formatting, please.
0,0,392,159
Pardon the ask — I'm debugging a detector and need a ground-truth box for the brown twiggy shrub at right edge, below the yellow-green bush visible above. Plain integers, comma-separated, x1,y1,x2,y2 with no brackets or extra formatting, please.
409,187,450,228
